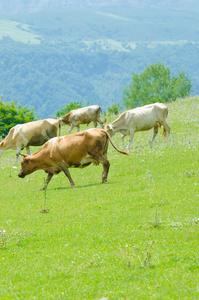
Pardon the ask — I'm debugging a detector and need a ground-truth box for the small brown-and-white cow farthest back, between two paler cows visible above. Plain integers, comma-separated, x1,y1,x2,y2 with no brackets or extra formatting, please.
61,105,106,134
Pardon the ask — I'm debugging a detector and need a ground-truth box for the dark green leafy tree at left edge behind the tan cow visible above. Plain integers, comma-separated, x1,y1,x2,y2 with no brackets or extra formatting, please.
0,99,36,137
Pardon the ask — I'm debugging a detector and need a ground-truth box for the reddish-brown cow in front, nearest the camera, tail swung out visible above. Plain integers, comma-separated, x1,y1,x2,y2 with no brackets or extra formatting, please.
18,128,130,189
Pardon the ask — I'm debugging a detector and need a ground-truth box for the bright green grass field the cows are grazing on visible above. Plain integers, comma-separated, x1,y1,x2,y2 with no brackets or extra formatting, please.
0,97,199,300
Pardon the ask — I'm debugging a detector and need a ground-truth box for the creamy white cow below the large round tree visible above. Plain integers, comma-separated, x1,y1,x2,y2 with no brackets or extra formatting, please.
104,103,170,151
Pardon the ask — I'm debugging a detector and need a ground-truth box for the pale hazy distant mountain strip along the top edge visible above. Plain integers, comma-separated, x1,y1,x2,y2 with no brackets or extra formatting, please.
0,0,199,14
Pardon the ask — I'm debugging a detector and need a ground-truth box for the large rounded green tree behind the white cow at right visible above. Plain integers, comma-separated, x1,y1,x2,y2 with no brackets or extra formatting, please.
123,63,192,109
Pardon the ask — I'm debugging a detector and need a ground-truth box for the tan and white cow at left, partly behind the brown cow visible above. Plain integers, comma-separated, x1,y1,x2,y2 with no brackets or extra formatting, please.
0,119,60,163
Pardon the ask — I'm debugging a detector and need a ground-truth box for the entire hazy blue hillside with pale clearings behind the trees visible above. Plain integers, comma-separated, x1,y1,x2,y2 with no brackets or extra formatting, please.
0,6,199,118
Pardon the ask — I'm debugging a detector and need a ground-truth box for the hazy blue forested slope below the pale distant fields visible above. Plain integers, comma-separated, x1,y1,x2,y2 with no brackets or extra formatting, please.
0,38,199,119
